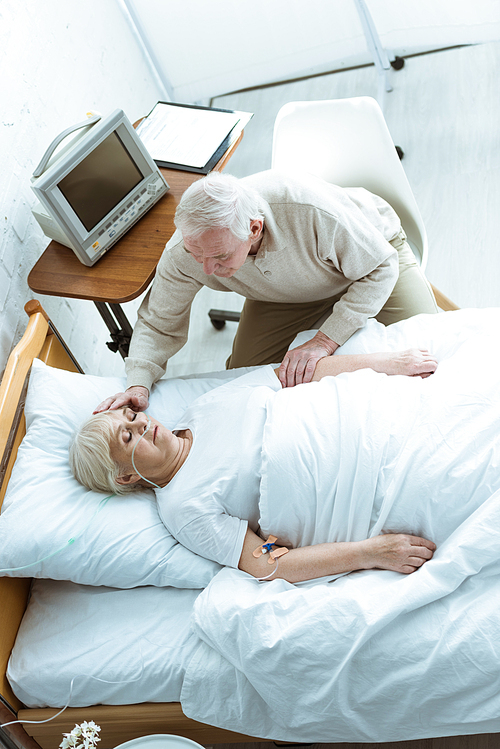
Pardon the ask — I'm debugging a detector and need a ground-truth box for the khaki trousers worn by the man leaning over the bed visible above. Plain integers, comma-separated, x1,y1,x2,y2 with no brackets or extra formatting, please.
226,231,438,369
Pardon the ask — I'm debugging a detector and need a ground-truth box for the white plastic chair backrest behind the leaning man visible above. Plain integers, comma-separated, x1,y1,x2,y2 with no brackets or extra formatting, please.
272,96,427,269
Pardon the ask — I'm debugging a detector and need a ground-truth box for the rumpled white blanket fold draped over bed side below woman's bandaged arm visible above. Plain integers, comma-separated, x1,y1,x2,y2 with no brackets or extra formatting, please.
181,512,500,743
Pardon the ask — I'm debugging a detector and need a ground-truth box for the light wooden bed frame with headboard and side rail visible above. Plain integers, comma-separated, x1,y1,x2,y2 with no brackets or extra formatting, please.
0,301,258,749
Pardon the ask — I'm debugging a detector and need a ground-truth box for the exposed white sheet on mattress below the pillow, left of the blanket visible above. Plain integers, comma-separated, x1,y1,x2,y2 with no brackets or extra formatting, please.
7,580,200,707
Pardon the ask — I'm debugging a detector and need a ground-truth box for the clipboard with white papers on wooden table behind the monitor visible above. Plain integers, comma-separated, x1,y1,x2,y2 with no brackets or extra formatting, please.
136,101,253,174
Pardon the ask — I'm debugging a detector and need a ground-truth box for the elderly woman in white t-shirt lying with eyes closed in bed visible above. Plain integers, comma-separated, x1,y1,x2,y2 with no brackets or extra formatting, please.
70,349,437,582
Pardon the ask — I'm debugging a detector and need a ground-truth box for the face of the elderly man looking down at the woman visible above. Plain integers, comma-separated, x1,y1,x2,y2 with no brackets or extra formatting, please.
183,220,262,278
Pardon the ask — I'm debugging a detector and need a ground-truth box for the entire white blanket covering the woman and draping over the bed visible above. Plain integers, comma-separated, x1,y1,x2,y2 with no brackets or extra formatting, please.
181,310,500,742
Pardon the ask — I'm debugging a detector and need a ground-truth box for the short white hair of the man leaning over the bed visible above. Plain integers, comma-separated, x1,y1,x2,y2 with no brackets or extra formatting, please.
174,172,265,242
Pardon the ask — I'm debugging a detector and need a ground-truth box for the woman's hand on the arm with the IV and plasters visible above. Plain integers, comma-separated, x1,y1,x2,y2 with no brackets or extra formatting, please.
360,533,436,575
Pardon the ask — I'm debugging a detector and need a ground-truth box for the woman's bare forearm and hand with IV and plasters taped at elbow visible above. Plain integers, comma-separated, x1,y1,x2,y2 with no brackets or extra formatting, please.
238,529,436,583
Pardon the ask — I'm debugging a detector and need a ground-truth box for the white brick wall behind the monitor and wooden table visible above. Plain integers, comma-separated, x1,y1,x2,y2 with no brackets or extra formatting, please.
0,0,161,374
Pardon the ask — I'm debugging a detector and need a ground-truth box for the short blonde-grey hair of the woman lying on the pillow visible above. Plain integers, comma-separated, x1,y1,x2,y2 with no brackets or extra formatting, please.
69,411,141,494
